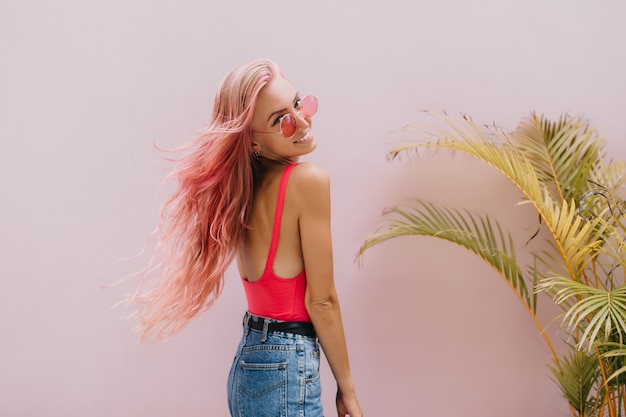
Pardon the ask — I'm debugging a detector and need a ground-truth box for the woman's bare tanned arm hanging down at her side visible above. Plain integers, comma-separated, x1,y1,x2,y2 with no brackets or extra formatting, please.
294,163,363,417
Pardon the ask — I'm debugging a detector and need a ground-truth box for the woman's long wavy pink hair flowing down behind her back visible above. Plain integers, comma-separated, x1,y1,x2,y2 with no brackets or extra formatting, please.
131,60,281,342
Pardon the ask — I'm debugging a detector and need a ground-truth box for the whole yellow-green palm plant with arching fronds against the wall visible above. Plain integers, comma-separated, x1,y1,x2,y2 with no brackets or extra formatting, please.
358,113,626,417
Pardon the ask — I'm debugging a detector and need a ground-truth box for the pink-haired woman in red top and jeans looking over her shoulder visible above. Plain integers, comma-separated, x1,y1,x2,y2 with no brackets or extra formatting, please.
134,60,363,417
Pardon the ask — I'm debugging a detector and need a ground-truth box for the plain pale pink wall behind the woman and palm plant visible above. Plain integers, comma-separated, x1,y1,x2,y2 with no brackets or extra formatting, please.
0,0,626,417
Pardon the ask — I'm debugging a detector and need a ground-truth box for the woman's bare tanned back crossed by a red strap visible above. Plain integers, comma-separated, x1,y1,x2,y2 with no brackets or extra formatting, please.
237,165,304,282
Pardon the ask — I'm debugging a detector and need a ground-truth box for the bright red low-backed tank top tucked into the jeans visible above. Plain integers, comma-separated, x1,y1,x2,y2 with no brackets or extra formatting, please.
242,164,311,322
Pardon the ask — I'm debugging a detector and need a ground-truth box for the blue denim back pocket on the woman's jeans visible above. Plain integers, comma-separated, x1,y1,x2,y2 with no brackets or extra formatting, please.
238,361,287,417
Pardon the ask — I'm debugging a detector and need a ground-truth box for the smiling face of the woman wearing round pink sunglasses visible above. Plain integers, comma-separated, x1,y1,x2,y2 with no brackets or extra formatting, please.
252,77,317,162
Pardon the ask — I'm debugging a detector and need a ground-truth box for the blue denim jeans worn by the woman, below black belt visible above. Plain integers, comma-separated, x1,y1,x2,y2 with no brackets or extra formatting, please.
228,313,323,417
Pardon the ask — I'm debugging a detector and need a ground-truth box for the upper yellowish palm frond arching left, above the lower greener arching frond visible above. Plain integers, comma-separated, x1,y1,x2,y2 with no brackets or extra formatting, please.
389,117,599,288
